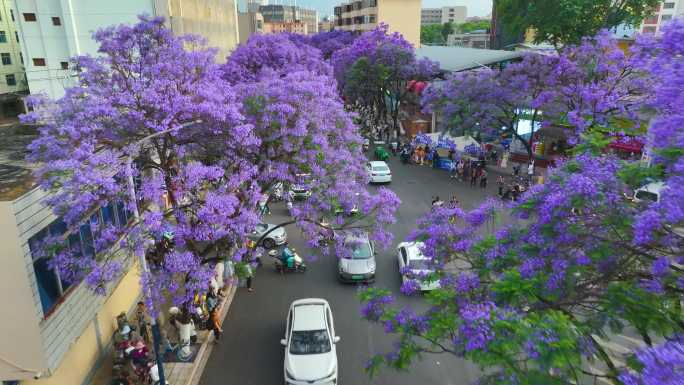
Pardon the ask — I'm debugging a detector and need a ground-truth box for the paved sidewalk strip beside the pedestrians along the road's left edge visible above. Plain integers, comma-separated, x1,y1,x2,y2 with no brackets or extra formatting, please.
90,285,237,385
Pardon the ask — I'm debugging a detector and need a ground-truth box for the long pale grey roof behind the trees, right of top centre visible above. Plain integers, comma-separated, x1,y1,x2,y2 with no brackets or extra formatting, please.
416,46,524,72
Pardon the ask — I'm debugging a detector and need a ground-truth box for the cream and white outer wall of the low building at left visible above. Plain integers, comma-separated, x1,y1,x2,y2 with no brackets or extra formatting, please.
0,189,139,385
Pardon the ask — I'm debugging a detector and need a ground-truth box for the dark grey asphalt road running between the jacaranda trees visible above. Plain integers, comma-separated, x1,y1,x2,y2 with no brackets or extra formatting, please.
200,153,496,385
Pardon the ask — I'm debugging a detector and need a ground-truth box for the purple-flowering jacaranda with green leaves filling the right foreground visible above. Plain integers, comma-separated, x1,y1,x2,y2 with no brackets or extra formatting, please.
362,22,684,385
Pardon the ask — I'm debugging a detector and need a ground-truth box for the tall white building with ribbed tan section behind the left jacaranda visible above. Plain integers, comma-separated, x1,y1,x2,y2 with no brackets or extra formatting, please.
13,0,238,98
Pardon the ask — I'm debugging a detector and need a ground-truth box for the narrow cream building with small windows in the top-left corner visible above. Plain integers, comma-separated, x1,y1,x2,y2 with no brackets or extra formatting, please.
0,0,28,118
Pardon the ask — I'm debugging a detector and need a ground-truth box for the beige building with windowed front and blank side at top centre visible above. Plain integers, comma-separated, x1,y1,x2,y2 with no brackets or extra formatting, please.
335,0,421,47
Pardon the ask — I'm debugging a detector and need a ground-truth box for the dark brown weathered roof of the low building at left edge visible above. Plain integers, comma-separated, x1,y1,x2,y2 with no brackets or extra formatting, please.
0,123,38,202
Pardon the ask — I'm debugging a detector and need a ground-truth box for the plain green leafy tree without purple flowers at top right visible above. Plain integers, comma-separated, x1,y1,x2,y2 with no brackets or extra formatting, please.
497,0,660,46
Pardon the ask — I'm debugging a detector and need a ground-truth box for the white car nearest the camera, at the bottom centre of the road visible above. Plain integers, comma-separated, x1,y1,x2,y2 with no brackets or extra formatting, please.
280,298,340,385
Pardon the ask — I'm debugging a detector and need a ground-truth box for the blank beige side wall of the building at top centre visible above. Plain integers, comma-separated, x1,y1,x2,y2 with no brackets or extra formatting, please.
378,0,421,47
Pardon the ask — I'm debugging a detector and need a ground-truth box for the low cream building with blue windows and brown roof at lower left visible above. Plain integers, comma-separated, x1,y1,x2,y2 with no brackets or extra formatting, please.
0,123,140,385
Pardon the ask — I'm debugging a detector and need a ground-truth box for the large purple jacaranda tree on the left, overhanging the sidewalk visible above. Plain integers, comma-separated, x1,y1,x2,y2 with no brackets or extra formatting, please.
24,16,398,312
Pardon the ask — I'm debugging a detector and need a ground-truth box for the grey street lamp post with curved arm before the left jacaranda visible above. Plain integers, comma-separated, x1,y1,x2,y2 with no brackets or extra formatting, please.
126,120,202,385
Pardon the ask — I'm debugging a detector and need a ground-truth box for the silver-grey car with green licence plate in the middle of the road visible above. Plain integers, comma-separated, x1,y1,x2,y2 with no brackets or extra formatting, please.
335,233,376,283
